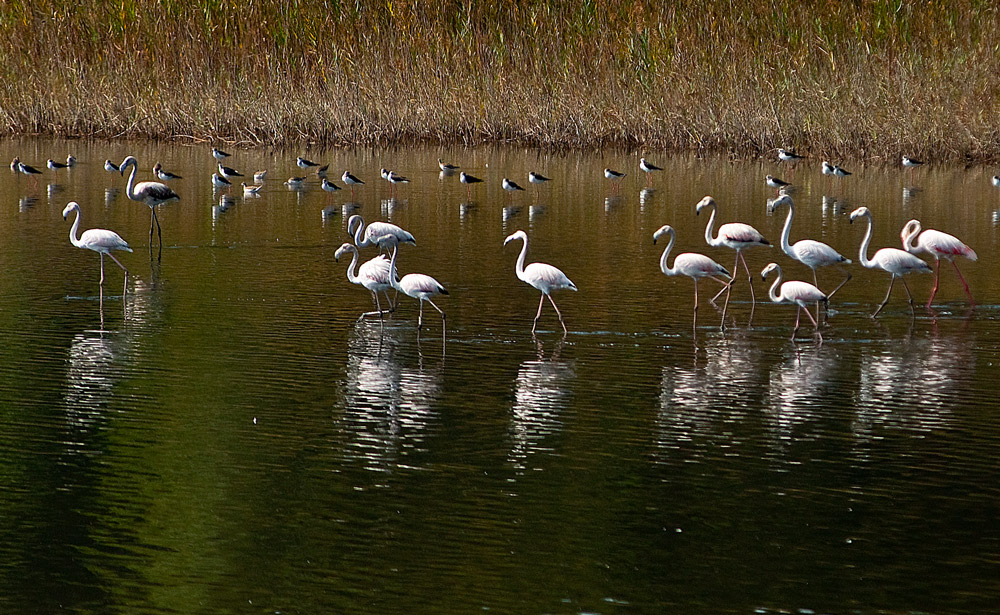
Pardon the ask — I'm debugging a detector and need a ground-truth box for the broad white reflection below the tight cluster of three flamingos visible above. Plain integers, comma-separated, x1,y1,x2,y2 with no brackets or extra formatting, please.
342,321,441,472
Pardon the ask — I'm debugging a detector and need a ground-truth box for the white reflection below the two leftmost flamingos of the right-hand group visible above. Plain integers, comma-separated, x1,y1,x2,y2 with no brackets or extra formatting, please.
656,336,766,457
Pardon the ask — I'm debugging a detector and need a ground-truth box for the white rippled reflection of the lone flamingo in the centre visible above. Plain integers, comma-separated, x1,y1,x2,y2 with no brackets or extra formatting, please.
508,339,576,471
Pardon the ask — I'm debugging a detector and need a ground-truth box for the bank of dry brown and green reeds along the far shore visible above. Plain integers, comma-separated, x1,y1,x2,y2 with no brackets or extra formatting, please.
0,0,1000,161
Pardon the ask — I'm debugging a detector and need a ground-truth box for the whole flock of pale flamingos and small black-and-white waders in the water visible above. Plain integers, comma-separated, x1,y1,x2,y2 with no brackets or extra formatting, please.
10,148,976,341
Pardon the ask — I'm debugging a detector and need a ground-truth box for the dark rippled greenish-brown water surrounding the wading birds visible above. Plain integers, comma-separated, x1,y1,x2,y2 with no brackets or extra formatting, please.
0,141,1000,614
